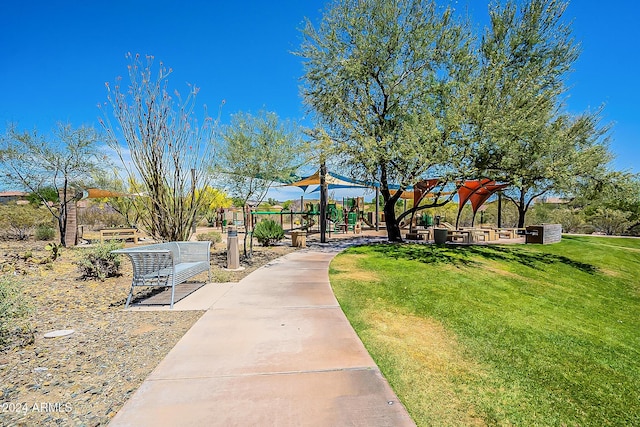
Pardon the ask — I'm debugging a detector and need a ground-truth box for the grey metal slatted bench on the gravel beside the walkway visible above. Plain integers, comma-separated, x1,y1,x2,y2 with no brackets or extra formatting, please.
113,242,211,308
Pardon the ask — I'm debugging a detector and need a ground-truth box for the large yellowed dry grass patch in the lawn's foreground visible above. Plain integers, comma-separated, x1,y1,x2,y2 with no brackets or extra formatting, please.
362,310,485,426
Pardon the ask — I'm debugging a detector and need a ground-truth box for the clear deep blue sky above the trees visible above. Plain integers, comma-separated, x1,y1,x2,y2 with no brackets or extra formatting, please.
0,0,640,196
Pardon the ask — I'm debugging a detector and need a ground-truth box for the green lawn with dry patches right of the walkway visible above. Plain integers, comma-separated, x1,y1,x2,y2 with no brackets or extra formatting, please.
330,236,640,426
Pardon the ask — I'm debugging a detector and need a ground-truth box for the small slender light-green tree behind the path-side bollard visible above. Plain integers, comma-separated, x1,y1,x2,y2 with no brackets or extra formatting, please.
217,111,307,256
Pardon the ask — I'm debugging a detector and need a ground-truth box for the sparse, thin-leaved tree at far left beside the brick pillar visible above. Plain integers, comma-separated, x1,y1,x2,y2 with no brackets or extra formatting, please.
0,124,108,245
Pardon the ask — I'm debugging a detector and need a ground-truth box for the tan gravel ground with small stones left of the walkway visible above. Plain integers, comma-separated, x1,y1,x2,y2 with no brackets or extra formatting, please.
0,242,293,426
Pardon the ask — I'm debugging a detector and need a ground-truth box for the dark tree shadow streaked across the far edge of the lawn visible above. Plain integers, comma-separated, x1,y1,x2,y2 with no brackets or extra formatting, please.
358,243,598,274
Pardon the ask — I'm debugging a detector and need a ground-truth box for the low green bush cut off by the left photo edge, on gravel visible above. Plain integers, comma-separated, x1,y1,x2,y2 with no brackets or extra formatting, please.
0,274,33,348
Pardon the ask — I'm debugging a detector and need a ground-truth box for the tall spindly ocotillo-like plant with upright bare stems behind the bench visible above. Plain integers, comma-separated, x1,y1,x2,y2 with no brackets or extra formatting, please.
102,54,217,241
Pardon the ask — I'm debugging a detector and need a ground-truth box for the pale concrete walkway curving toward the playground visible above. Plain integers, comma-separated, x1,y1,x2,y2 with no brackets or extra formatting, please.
110,242,415,427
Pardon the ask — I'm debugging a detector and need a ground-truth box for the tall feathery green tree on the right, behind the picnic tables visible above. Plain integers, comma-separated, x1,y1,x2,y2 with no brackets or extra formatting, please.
470,0,611,227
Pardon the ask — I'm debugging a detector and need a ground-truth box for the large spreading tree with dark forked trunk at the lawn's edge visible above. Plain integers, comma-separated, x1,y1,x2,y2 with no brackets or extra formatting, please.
297,0,474,241
